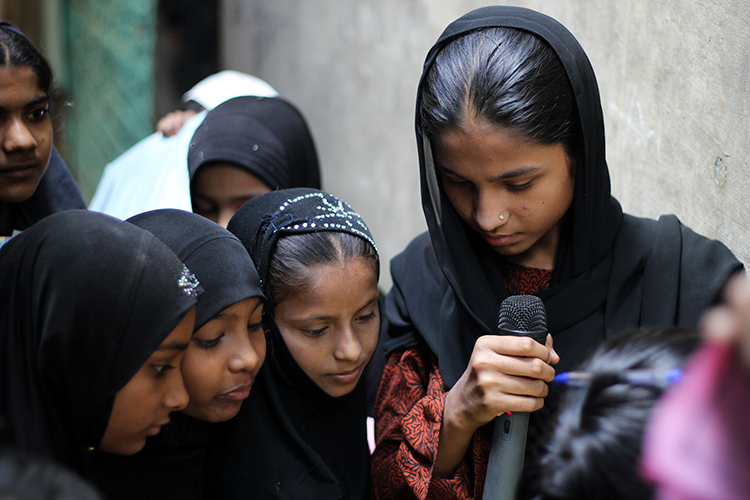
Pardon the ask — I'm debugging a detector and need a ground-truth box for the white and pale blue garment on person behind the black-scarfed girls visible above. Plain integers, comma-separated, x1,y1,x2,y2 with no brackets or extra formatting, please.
89,70,279,219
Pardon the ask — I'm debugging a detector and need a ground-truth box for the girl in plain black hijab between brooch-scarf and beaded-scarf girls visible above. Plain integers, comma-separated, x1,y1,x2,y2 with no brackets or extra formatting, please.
94,209,266,500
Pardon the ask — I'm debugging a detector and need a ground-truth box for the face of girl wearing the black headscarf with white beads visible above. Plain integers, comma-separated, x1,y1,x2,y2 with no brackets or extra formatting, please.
275,257,380,397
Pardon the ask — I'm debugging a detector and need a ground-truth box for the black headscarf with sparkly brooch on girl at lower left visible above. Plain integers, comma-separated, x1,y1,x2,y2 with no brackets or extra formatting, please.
0,210,200,472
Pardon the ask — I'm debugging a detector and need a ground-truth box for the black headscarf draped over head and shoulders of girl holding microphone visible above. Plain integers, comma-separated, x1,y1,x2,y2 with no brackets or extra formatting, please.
386,7,741,442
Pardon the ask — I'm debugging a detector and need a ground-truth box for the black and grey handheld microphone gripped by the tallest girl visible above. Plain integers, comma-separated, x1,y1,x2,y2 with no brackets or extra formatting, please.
482,295,547,500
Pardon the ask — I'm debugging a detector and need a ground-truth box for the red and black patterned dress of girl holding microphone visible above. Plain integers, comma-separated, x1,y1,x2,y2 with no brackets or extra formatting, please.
372,262,552,500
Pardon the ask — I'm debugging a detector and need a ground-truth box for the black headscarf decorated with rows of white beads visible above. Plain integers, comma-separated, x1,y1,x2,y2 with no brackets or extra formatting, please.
205,189,375,500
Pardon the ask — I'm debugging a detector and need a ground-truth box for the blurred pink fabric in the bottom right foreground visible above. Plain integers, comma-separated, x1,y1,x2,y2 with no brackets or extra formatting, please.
642,343,750,500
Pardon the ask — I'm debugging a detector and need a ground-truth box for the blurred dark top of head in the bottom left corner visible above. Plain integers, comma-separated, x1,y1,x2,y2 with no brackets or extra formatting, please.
0,451,102,500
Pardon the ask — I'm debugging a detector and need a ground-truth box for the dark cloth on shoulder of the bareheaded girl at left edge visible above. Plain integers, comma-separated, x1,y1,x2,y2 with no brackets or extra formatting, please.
0,146,86,231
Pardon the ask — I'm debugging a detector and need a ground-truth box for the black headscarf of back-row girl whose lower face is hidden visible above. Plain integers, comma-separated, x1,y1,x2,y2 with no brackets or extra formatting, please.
188,96,320,189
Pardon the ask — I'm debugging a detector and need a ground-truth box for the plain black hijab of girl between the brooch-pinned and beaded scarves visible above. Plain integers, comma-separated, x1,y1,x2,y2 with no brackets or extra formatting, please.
94,209,263,500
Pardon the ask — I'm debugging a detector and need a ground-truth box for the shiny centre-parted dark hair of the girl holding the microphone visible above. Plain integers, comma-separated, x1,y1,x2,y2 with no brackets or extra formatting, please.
419,28,581,158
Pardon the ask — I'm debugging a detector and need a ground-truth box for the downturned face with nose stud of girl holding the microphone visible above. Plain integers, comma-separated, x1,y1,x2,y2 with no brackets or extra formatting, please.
433,119,575,269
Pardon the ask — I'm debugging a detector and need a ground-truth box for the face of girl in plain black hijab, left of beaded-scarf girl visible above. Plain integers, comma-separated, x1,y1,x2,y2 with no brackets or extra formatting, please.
182,297,266,422
